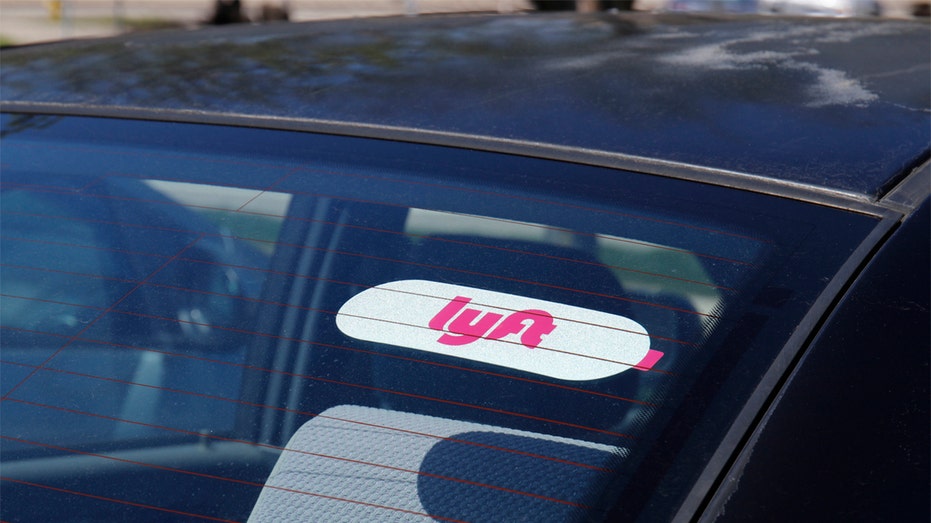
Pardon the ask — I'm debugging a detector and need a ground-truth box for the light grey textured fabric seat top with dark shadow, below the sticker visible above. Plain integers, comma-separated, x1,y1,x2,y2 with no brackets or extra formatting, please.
249,405,626,523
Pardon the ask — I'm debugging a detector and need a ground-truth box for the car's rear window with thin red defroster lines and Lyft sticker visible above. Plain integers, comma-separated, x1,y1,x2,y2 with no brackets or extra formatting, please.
0,115,876,521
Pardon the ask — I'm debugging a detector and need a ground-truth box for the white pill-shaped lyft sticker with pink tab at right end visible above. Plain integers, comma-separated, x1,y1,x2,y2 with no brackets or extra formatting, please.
336,280,663,381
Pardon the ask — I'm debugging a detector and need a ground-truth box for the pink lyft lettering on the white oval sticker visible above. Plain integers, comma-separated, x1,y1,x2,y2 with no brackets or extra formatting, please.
428,296,556,349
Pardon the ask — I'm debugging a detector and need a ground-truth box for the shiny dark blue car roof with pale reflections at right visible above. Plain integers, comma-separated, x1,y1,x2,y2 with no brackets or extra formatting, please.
0,14,931,200
